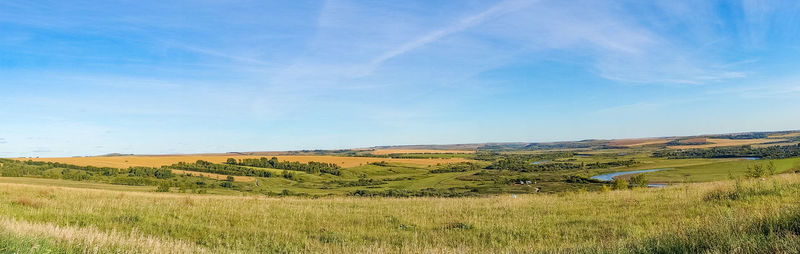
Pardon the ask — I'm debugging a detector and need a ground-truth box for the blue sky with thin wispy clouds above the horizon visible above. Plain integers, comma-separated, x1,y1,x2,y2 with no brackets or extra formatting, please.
0,0,800,157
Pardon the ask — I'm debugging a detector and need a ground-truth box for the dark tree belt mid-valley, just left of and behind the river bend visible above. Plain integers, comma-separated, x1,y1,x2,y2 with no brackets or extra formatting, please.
487,157,639,172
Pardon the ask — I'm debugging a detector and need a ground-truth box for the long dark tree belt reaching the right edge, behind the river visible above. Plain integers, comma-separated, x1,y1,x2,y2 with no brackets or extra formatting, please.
653,144,800,159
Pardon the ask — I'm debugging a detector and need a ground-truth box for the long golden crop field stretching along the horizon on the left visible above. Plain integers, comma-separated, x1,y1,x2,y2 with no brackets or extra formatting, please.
21,154,476,168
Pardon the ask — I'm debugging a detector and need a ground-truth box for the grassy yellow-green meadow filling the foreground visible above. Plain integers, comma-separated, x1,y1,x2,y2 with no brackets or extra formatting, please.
0,174,800,253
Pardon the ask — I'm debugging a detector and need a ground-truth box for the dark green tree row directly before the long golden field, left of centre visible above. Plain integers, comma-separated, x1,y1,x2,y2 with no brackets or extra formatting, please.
226,157,341,176
